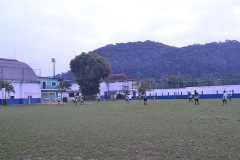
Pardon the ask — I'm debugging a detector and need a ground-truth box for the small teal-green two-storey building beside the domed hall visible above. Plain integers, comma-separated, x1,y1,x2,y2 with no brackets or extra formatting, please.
38,77,59,101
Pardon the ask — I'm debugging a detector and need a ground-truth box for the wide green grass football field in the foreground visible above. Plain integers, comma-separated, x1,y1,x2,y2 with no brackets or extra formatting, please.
0,99,240,160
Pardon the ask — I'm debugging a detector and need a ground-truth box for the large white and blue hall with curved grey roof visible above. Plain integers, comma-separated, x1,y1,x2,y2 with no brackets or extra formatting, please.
0,58,41,105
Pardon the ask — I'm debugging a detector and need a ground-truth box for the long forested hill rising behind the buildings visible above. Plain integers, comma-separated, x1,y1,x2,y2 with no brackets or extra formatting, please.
90,40,240,79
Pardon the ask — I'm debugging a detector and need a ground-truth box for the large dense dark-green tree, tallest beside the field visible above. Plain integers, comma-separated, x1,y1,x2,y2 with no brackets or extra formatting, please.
70,52,111,95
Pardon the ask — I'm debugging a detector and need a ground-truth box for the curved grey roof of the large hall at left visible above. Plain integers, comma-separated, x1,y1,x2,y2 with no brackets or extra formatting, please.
0,58,39,82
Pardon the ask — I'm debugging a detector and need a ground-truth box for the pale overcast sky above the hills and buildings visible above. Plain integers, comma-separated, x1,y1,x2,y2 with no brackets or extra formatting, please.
0,0,240,77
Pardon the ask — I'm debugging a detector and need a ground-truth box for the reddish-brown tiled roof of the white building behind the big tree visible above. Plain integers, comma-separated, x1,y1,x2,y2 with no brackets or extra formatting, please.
102,74,139,82
